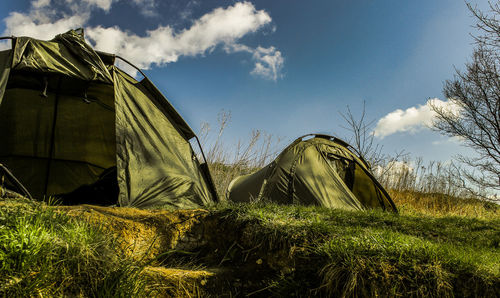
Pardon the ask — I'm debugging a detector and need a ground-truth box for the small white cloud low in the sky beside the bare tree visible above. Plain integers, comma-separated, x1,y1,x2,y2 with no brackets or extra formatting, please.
374,98,460,139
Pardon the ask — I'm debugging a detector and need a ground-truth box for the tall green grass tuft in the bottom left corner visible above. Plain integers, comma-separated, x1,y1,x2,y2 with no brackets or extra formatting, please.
0,200,145,297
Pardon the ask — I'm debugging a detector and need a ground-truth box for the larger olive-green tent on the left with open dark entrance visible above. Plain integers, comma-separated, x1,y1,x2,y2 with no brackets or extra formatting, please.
0,29,217,208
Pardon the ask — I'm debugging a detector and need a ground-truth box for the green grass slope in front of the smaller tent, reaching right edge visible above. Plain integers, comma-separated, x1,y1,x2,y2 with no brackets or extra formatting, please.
204,203,500,297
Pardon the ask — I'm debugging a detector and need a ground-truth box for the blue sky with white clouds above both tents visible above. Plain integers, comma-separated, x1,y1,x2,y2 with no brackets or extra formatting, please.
0,0,487,161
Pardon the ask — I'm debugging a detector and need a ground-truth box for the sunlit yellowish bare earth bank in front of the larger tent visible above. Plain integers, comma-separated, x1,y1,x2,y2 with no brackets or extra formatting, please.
58,205,208,261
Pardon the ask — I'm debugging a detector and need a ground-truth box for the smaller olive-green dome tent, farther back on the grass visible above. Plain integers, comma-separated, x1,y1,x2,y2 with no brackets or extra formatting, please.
227,134,397,212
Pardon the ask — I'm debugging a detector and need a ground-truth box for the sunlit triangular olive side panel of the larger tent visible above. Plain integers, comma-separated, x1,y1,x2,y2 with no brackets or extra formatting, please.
114,69,210,208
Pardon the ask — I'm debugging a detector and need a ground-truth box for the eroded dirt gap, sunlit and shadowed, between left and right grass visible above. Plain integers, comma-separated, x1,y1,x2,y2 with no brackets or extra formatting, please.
58,205,316,297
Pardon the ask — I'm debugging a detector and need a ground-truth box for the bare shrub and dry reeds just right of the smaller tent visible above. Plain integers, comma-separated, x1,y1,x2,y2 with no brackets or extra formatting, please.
340,104,496,200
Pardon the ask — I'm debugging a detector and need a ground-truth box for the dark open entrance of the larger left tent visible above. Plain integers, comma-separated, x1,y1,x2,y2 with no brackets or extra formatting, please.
0,70,116,198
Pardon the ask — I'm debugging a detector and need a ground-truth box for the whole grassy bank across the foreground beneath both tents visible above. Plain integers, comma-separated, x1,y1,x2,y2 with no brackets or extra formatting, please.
0,193,500,297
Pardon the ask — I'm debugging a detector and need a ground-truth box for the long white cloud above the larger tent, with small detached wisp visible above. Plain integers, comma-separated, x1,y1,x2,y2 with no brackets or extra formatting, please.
86,2,276,77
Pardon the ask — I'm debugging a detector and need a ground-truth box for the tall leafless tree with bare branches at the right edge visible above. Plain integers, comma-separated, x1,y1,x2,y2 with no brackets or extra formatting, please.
432,2,500,196
